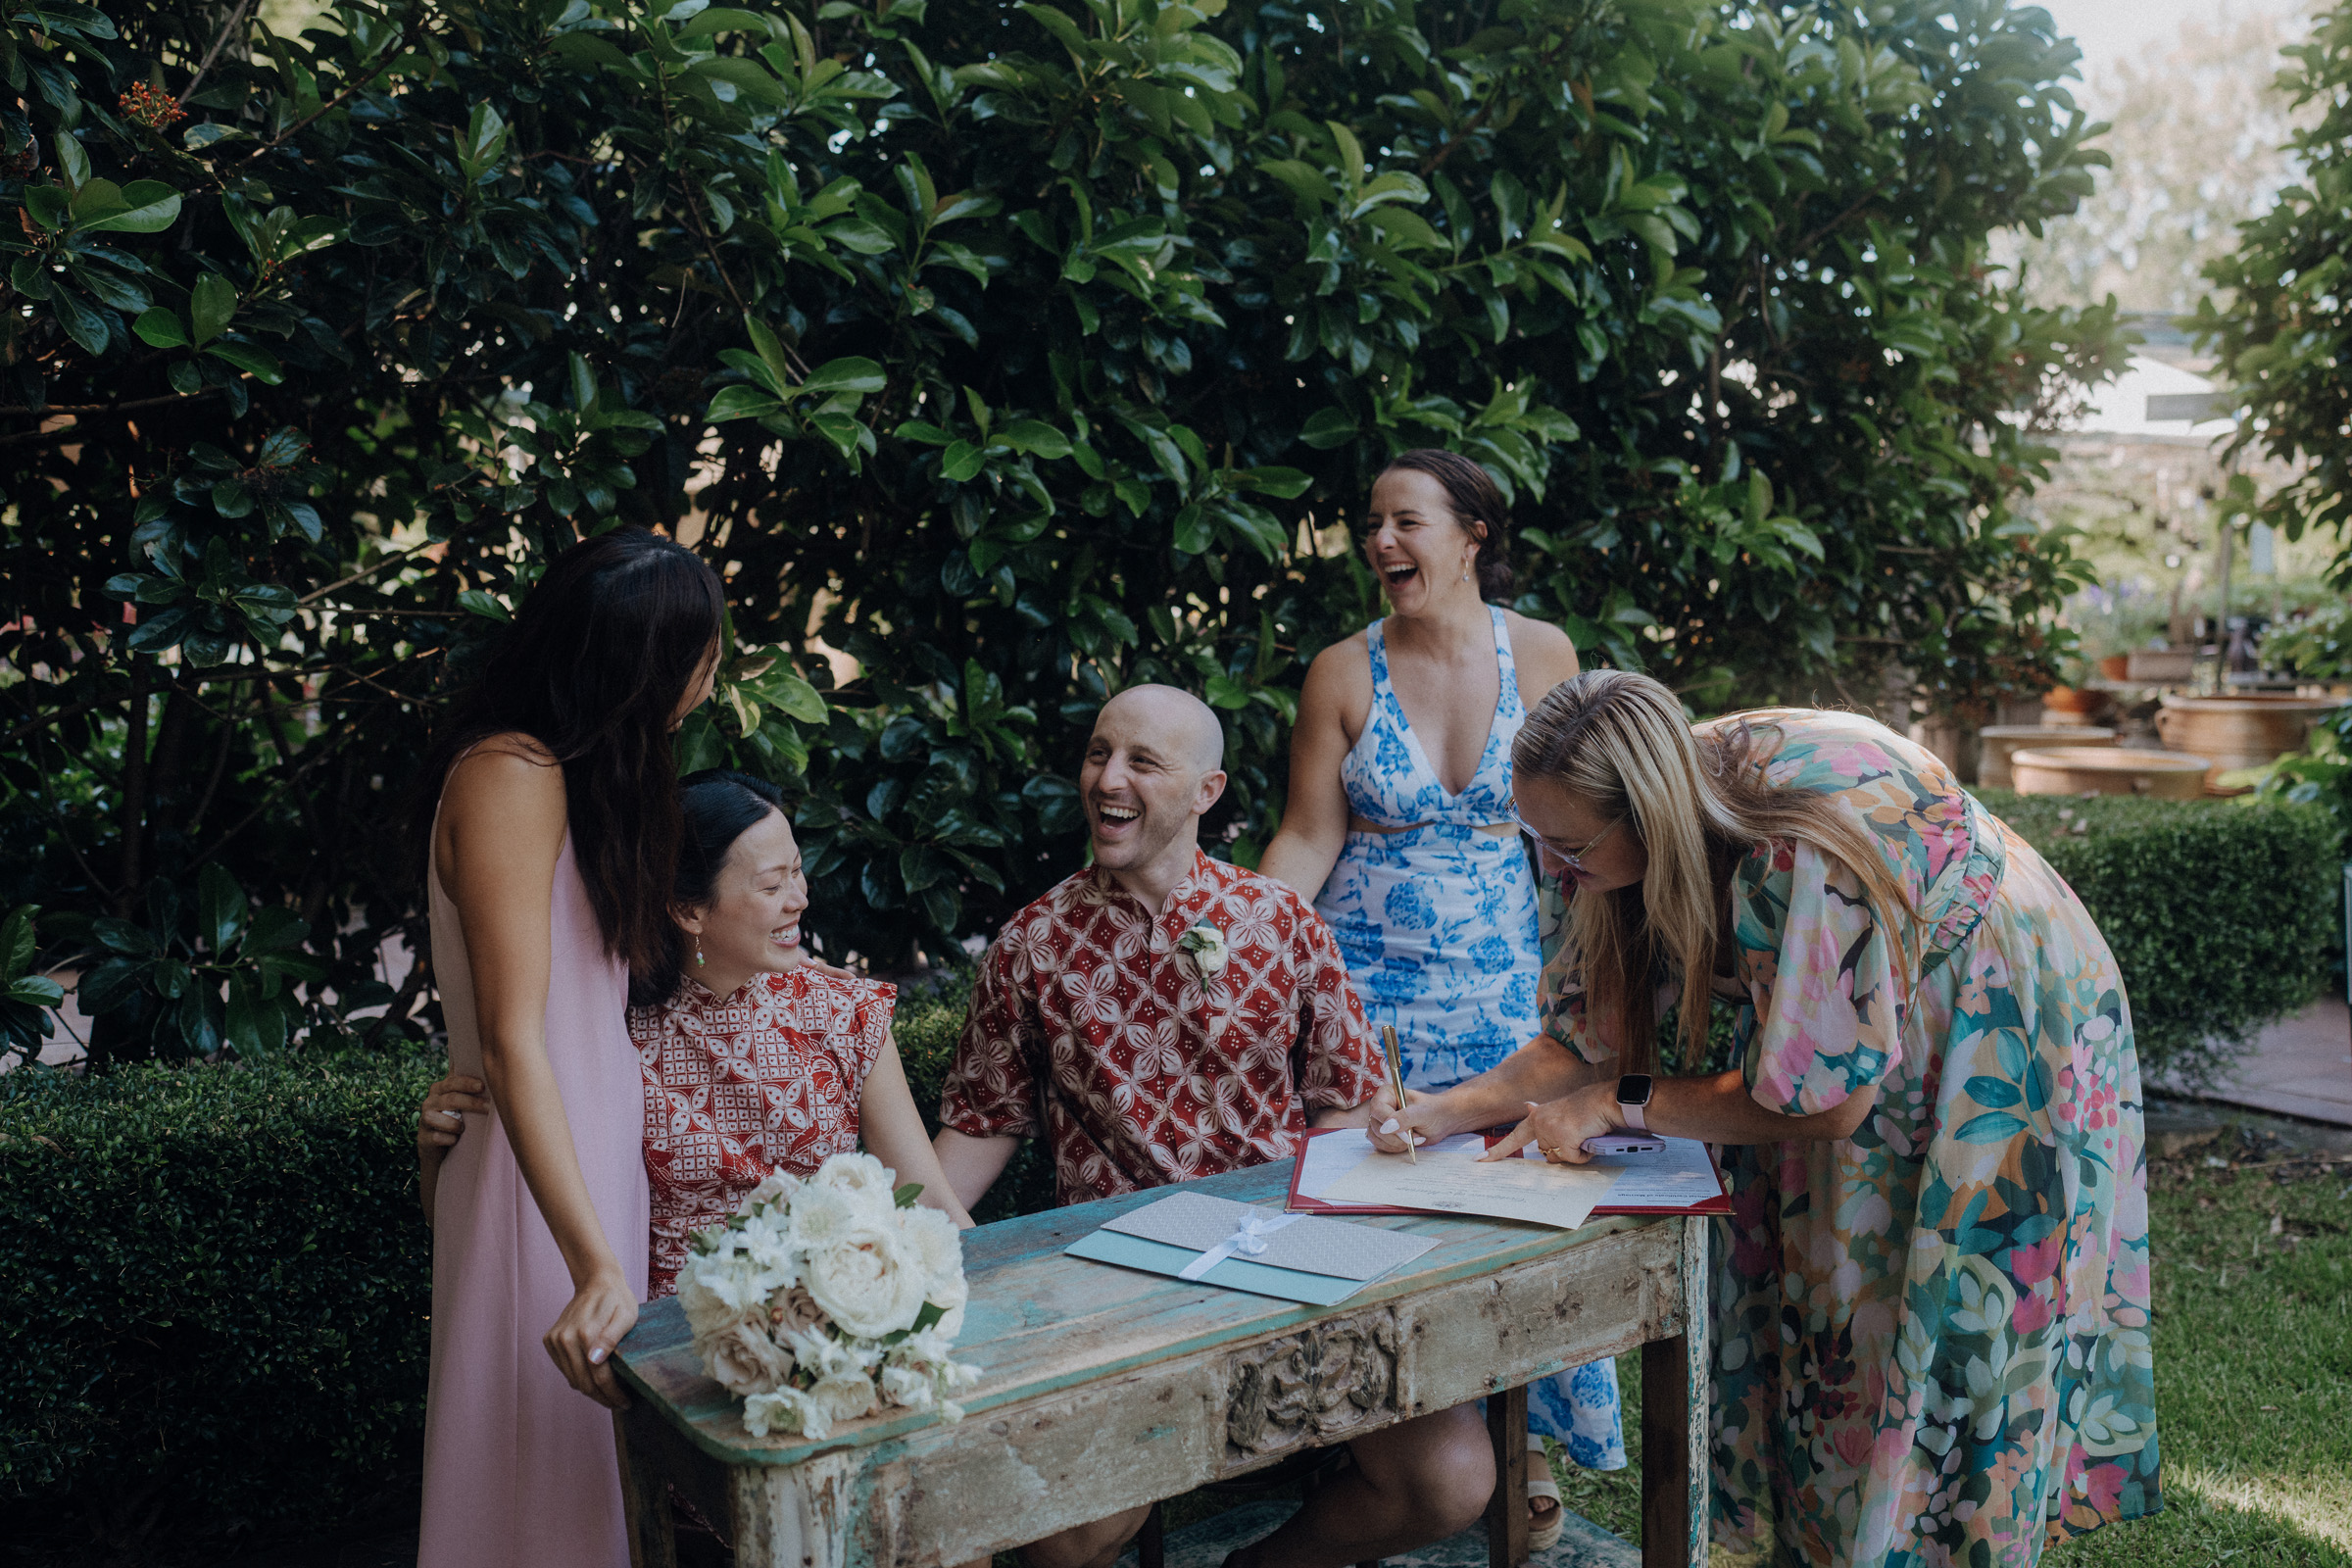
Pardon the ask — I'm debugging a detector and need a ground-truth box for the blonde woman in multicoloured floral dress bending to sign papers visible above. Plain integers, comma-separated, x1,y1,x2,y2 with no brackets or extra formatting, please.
1386,670,2159,1568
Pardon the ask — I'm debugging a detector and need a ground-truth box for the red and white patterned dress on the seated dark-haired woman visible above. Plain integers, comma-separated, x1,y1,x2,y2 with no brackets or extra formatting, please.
628,968,899,1300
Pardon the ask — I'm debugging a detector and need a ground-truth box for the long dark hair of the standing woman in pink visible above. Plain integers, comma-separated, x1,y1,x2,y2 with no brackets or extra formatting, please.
418,529,727,968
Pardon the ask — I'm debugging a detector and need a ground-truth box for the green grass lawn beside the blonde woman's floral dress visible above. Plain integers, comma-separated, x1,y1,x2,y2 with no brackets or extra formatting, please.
1554,1133,2352,1568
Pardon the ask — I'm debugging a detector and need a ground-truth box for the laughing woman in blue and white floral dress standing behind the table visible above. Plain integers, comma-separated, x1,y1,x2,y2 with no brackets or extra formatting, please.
1258,452,1625,1549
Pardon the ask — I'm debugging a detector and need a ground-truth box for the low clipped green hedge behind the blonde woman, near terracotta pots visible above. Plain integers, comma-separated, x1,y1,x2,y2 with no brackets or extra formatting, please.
1983,790,2338,1081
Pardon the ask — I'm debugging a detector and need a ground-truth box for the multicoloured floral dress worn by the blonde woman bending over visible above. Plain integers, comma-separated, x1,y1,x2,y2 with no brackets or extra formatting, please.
1545,710,2159,1568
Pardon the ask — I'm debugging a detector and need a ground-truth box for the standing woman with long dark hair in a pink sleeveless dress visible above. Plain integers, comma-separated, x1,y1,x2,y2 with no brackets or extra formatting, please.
416,529,724,1568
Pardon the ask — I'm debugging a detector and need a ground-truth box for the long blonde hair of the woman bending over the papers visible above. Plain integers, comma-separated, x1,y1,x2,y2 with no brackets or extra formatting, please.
1510,670,1919,1072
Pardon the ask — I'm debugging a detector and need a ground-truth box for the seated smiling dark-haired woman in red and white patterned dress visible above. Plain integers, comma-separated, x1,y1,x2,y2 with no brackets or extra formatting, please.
416,768,971,1300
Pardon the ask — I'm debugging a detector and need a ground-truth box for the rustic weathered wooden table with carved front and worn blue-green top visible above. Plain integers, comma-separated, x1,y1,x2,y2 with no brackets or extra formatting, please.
616,1163,1707,1568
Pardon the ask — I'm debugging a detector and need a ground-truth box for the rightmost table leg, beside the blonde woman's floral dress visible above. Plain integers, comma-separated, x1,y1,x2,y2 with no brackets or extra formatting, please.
1642,1215,1715,1568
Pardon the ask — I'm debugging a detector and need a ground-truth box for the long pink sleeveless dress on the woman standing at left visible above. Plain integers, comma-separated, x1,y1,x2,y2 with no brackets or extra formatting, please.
416,832,647,1568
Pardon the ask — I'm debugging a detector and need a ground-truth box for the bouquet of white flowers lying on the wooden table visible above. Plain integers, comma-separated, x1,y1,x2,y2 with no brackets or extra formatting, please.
677,1154,981,1439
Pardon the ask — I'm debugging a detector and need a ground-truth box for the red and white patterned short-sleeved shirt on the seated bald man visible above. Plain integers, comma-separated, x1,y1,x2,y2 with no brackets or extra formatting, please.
939,856,1386,1203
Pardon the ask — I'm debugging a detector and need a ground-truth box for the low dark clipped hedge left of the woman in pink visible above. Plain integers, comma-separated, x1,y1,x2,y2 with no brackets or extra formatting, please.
0,1054,440,1561
